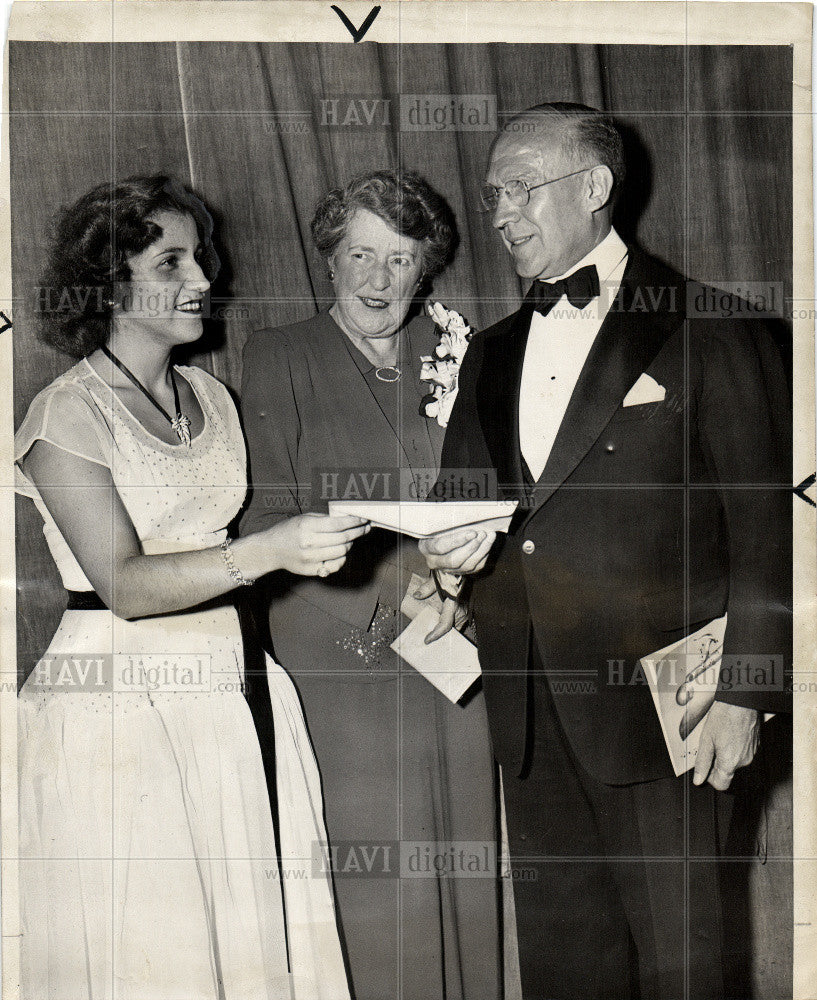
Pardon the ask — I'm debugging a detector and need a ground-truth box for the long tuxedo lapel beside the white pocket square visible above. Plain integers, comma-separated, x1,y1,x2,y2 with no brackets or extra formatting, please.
516,250,685,517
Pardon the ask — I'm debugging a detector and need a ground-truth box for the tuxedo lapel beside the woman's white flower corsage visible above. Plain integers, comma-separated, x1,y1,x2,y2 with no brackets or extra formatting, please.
476,302,533,493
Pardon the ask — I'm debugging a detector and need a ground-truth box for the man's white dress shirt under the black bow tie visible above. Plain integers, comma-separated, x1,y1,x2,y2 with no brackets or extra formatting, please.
519,229,627,480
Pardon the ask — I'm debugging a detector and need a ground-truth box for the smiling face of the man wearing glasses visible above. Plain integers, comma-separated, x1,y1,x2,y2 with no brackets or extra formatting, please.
486,130,609,278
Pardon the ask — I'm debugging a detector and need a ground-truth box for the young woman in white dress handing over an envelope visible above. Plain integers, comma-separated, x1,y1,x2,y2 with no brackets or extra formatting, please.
15,176,358,1000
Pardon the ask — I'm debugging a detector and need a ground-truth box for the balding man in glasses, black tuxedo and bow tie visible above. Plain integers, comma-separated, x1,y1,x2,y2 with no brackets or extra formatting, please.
423,104,791,1000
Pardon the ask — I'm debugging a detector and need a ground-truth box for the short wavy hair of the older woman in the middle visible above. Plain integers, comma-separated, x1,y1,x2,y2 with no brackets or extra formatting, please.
312,170,459,280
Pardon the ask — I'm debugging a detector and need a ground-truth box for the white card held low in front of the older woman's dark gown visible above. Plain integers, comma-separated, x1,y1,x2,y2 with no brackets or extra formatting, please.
391,608,482,703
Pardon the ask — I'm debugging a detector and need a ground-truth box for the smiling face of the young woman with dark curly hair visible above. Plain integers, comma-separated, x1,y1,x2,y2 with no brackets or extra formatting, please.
114,211,210,346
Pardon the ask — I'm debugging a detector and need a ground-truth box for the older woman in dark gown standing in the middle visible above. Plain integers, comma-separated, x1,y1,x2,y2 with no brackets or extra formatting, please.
241,171,500,1000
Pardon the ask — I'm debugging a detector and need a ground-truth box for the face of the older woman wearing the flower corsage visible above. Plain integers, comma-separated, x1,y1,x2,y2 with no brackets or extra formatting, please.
329,208,423,340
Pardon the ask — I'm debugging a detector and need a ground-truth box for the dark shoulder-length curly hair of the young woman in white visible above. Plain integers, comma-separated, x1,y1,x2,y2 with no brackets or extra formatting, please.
37,174,219,358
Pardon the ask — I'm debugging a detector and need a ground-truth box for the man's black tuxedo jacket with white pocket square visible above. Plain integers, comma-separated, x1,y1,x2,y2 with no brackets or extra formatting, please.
439,248,792,784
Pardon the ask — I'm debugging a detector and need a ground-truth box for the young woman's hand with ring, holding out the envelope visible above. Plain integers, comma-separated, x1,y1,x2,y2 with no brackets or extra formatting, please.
262,514,371,577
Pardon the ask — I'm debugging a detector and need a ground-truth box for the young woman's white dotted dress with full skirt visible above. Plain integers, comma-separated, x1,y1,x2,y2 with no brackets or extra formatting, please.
15,361,349,1000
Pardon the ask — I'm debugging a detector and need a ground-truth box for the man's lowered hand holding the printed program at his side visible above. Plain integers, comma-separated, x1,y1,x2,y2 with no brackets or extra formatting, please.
693,701,760,792
